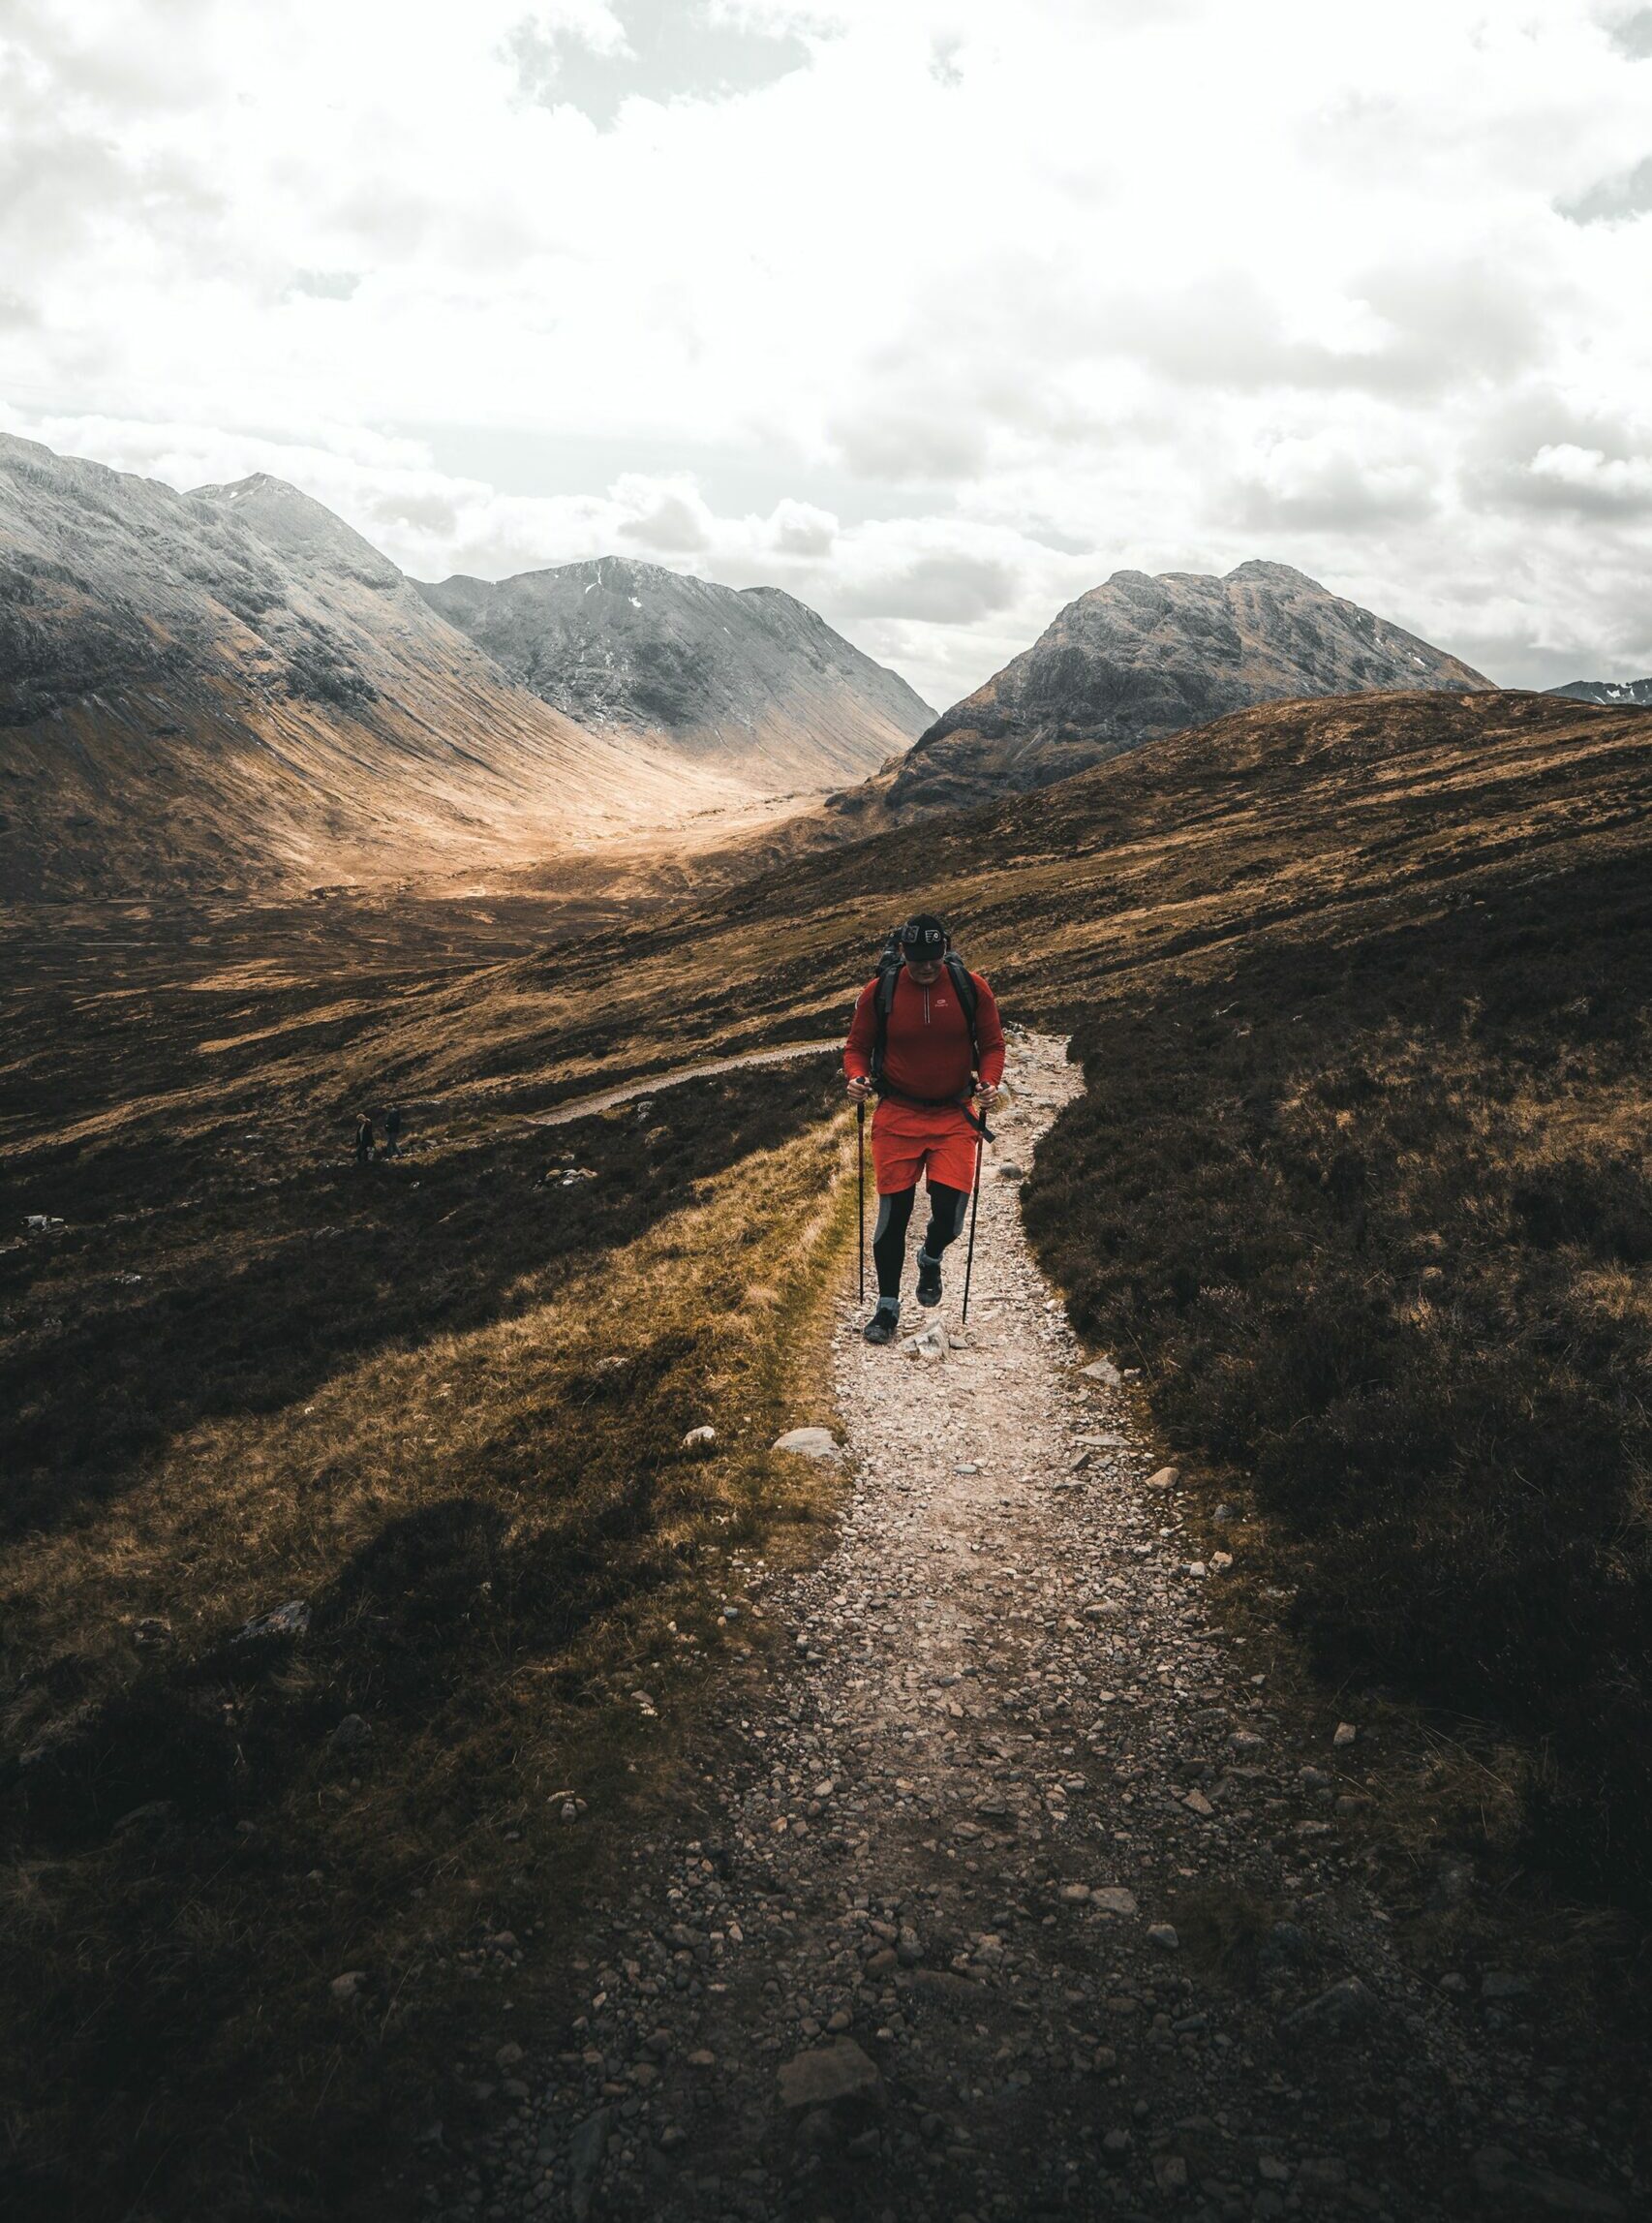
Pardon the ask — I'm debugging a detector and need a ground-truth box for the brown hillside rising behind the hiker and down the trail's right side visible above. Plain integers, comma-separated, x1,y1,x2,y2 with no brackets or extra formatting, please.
291,694,1652,1897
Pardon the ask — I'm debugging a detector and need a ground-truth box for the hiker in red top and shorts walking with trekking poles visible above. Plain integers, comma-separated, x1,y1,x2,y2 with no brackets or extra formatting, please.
842,911,1003,1343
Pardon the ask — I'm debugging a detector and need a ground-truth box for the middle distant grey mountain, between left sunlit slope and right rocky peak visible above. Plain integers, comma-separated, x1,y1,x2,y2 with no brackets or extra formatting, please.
418,556,933,789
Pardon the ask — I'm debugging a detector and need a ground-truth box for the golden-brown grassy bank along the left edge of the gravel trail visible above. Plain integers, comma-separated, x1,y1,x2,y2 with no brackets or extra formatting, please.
0,1058,847,2216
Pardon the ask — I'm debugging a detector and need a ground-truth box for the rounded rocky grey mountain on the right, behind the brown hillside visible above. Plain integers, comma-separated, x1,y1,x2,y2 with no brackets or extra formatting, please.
884,563,1492,818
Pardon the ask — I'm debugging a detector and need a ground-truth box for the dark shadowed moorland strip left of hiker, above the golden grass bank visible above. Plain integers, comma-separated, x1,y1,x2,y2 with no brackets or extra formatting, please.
0,1063,829,1536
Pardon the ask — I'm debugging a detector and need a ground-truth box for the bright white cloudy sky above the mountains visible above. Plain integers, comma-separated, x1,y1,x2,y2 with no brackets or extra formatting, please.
0,0,1652,705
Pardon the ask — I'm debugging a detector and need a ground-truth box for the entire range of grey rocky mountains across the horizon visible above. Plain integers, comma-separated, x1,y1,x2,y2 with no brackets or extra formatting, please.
0,436,1520,896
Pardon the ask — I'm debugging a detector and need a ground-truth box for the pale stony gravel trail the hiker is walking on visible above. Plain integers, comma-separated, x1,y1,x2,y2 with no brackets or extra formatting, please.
422,1035,1637,2223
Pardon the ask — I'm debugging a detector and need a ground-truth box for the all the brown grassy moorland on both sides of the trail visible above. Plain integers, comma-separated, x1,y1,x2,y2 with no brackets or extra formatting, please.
0,694,1652,2216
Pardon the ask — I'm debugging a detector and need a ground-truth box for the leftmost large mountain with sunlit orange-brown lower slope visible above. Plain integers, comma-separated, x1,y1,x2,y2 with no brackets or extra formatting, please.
0,436,736,898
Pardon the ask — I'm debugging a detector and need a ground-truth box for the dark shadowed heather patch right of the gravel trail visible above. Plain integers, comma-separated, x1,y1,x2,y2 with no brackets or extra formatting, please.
1027,840,1652,1903
